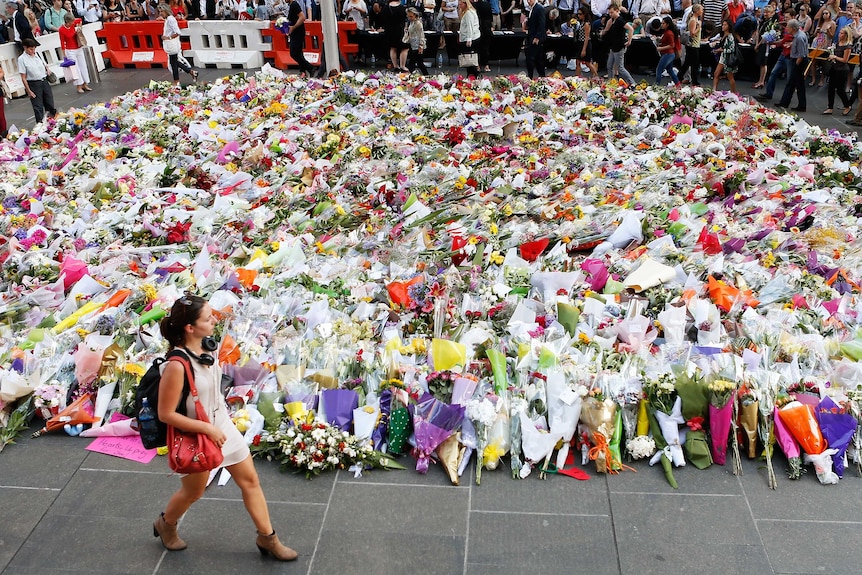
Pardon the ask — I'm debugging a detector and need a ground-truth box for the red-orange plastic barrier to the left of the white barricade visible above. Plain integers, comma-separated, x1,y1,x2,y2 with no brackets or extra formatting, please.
96,20,190,68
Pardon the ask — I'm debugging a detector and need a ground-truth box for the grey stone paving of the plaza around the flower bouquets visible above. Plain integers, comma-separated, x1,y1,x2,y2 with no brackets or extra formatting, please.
0,63,862,575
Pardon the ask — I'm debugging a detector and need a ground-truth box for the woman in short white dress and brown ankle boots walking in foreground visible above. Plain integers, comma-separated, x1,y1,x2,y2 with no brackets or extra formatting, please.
153,294,297,561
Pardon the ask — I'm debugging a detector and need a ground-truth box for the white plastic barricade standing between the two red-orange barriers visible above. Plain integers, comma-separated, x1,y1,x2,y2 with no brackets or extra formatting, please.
183,20,272,68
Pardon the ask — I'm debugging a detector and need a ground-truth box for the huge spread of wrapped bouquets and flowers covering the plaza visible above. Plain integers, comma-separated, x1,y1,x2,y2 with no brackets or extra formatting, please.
0,69,862,486
